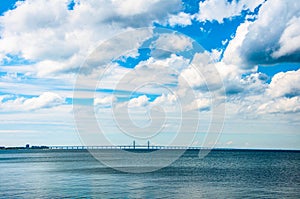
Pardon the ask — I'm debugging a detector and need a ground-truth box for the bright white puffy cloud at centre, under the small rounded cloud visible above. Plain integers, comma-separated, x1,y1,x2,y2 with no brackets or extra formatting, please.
110,54,189,94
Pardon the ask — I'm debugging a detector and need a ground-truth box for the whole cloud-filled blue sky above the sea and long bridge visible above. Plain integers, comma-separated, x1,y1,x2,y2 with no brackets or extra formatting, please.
0,0,300,149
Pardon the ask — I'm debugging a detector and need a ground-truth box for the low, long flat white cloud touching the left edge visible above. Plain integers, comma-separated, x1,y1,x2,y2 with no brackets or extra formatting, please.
0,92,65,111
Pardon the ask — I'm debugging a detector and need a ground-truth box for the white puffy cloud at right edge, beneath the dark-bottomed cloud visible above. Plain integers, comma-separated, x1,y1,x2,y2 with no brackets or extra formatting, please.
227,70,300,117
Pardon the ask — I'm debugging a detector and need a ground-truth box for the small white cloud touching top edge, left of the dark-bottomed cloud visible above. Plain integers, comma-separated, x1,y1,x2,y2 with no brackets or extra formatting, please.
196,0,264,23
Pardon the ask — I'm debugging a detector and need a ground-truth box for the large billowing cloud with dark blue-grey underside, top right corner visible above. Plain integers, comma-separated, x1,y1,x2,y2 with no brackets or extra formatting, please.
224,0,300,68
